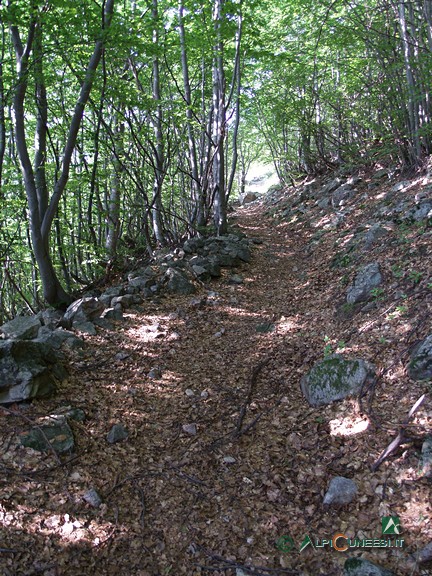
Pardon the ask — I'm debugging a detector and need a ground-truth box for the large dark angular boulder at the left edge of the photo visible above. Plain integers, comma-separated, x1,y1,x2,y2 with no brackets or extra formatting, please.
0,340,67,404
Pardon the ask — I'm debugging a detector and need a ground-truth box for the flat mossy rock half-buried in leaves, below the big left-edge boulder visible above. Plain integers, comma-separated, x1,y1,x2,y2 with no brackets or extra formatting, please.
20,414,75,454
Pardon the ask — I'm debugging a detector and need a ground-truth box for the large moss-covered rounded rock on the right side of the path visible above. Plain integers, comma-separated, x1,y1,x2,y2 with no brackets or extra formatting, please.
300,354,374,406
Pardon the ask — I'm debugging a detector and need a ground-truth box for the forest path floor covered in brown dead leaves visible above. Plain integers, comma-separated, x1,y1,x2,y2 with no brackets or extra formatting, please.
0,172,432,576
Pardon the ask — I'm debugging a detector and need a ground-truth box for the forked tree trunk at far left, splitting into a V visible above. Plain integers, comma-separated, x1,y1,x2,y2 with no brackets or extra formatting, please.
9,0,115,306
